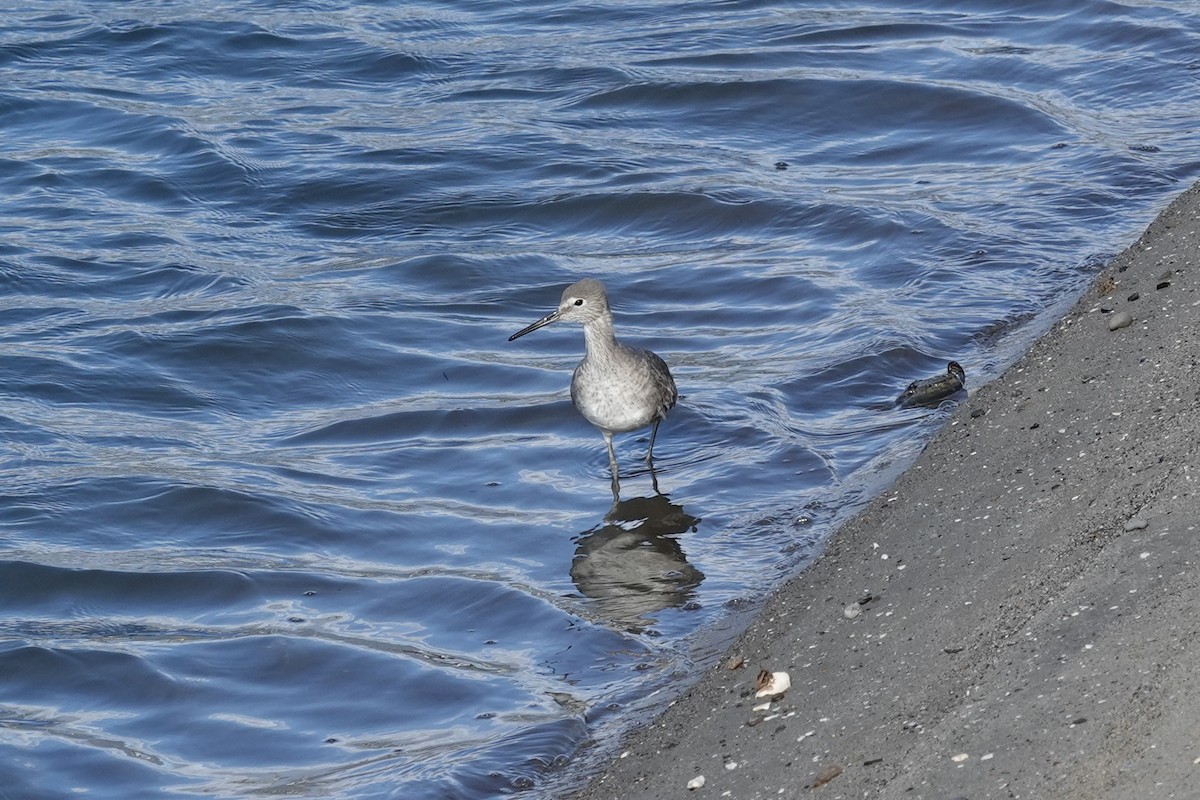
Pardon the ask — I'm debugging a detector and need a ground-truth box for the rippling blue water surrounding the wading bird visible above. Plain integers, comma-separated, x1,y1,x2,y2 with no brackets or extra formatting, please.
0,1,1200,800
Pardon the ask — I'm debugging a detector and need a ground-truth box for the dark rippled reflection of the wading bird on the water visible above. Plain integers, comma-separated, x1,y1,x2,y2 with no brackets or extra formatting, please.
571,494,704,633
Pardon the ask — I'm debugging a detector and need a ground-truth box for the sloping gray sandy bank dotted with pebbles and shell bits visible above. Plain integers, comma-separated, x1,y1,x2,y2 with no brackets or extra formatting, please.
576,185,1200,800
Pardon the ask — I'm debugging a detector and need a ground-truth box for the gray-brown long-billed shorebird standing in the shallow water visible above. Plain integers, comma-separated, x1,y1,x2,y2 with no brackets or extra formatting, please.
509,278,679,491
